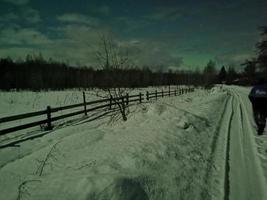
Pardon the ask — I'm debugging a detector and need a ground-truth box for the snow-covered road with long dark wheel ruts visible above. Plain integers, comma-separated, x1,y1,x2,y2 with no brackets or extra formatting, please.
217,88,267,200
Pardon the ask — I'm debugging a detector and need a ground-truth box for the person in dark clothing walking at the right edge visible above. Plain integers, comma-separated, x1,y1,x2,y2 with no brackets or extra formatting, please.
249,78,267,135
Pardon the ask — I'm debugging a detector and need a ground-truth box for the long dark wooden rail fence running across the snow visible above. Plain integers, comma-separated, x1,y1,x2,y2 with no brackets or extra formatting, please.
0,88,194,135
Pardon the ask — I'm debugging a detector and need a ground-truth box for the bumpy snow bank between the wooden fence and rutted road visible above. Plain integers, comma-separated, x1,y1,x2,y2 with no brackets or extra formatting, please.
0,86,232,200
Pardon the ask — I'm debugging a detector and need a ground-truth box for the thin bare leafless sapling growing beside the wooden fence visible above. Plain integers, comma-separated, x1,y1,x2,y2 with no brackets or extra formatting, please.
97,35,130,121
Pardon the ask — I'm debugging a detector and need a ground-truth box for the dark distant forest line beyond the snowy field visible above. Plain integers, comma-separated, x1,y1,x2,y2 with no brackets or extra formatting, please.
0,56,266,91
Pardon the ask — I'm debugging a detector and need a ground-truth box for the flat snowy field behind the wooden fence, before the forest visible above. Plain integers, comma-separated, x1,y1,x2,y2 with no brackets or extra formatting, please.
0,86,178,117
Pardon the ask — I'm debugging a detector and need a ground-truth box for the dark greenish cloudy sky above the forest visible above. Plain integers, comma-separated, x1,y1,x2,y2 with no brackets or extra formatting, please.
0,0,267,69
